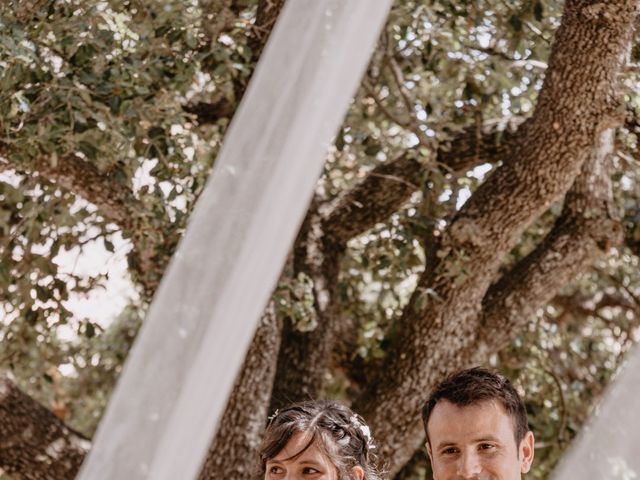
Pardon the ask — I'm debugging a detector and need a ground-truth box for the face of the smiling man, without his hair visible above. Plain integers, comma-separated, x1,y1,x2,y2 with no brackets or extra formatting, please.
427,400,533,480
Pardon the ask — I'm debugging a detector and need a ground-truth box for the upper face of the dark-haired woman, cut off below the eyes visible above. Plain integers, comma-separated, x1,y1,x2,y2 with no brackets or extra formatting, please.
264,432,339,480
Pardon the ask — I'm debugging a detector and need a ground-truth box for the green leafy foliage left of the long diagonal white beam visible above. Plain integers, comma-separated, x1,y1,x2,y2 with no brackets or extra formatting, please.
0,0,253,432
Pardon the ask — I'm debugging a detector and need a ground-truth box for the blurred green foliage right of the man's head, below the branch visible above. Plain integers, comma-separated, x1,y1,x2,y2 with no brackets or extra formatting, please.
500,250,640,479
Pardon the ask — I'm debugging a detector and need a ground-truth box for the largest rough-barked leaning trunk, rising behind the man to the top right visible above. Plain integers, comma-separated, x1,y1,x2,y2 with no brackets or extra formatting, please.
356,0,637,474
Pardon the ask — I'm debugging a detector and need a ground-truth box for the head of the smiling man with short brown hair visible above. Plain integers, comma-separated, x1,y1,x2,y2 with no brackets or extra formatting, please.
422,368,534,480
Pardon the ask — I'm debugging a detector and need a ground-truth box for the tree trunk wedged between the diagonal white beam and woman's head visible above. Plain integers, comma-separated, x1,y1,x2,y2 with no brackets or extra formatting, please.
200,303,282,480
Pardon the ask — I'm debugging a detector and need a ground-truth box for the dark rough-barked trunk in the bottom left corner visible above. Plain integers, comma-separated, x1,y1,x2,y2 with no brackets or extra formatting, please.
0,372,90,480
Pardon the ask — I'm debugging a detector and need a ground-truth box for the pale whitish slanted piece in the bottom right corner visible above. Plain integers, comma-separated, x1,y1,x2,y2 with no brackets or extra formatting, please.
553,347,640,480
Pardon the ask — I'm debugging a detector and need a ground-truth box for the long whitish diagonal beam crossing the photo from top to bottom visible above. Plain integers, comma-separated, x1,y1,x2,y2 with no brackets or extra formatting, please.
79,0,391,480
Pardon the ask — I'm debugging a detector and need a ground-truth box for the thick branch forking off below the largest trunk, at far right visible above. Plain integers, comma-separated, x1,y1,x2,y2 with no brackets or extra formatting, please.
476,130,622,352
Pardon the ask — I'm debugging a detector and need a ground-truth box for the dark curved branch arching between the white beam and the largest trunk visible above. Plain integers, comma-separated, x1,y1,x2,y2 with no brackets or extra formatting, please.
271,115,521,410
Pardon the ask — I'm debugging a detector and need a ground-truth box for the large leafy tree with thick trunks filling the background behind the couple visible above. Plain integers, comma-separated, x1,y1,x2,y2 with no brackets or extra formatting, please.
0,0,640,479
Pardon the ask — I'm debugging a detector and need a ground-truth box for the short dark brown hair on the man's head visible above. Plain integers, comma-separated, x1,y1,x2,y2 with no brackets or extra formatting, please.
422,367,529,445
